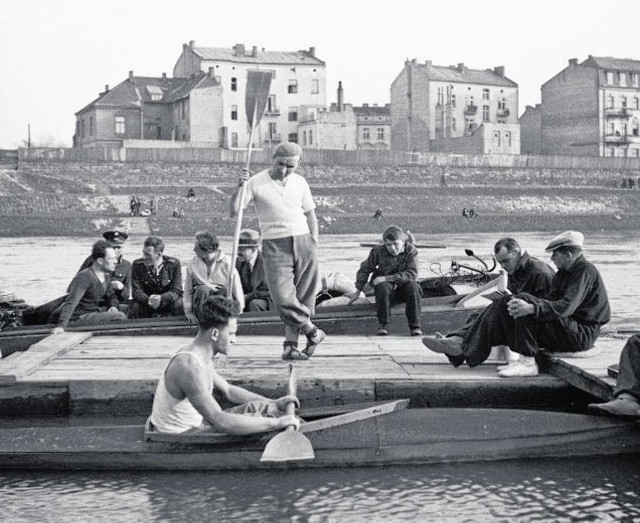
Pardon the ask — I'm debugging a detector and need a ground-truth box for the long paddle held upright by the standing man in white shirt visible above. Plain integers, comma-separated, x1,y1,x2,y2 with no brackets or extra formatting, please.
227,71,272,297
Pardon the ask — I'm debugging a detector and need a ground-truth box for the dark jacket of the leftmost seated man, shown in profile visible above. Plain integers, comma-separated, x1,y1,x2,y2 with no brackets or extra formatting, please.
58,269,118,328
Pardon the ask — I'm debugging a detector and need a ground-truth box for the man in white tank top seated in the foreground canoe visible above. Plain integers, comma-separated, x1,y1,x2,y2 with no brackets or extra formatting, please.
151,285,300,435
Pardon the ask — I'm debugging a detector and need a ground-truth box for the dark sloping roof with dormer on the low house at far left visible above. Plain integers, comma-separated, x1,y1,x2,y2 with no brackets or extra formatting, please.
76,73,220,114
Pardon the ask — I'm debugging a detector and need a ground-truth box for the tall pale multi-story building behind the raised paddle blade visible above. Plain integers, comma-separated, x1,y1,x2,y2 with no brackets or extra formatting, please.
173,41,327,148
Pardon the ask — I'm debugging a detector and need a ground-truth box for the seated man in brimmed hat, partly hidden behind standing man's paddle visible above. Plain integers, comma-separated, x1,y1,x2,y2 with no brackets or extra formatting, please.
236,229,273,312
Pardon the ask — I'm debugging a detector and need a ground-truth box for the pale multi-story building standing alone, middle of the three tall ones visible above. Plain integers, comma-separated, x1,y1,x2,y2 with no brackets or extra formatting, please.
391,59,520,154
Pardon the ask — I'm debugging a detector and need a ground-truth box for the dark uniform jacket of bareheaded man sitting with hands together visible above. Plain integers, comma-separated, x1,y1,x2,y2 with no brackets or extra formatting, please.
131,255,183,308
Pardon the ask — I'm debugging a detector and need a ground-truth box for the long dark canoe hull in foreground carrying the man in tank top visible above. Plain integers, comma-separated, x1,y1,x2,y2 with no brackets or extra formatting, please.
0,409,640,471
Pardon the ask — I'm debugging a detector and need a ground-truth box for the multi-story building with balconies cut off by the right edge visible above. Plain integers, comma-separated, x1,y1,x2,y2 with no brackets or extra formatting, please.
541,55,640,158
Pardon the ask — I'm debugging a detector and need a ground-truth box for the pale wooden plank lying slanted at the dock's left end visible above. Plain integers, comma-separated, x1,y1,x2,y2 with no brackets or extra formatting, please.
0,332,91,383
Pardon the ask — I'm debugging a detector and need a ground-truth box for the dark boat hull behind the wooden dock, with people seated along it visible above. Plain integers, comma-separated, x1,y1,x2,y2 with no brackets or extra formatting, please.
0,295,477,357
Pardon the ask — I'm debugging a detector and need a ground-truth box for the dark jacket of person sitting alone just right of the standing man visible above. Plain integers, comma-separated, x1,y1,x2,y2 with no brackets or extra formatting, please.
356,242,418,291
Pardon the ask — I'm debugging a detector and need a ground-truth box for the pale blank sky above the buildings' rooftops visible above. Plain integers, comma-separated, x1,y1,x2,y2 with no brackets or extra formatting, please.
0,0,640,148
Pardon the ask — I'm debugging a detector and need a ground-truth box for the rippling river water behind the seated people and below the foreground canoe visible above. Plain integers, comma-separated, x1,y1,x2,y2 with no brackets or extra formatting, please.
0,231,640,521
